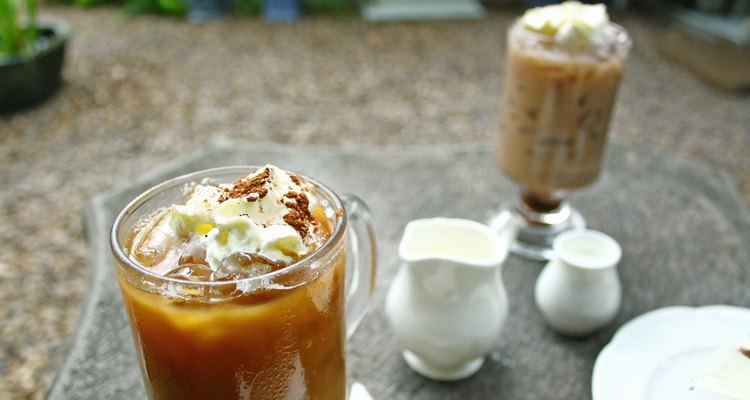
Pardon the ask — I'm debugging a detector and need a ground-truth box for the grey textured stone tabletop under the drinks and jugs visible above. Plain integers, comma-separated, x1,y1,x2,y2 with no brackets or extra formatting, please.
49,142,750,400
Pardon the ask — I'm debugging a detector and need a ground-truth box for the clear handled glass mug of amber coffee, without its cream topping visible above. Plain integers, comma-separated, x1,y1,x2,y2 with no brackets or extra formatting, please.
110,167,376,400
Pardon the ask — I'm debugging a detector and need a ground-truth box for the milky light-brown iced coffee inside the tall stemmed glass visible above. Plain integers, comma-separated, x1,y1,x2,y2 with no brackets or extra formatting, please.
497,22,629,202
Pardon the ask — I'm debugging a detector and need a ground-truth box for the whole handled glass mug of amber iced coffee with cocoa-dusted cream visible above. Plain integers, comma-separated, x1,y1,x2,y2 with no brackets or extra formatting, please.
111,165,375,400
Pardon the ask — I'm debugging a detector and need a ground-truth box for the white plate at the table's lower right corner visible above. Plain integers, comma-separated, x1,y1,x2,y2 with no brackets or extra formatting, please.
591,306,750,400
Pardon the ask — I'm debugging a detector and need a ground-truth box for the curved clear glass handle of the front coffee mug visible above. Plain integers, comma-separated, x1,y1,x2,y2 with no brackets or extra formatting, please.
339,194,377,339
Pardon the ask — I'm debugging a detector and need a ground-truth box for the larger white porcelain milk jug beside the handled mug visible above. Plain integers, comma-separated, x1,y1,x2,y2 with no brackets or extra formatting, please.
385,215,515,381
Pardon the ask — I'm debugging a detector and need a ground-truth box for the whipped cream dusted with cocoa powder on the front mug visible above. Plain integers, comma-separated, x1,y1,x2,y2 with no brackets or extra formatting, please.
168,165,318,271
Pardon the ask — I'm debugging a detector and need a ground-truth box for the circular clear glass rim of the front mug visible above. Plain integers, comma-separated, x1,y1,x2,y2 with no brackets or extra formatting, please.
109,165,348,288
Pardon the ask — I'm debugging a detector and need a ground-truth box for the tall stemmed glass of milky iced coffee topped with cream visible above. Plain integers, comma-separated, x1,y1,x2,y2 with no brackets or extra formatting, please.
489,1,631,260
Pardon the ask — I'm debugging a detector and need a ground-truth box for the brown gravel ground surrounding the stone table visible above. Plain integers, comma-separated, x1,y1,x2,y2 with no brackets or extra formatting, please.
0,7,750,399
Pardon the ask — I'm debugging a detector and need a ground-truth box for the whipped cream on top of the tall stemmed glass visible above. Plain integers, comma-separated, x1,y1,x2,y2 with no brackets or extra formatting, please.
521,1,609,42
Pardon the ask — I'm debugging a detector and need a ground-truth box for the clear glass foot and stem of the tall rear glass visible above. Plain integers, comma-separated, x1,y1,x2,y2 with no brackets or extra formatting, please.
487,201,586,261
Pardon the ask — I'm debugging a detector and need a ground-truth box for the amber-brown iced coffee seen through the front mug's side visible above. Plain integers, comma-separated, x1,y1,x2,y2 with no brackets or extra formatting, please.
113,248,346,400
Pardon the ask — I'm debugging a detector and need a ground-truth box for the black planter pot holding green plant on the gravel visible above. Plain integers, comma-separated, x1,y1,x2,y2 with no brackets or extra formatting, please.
0,23,70,112
